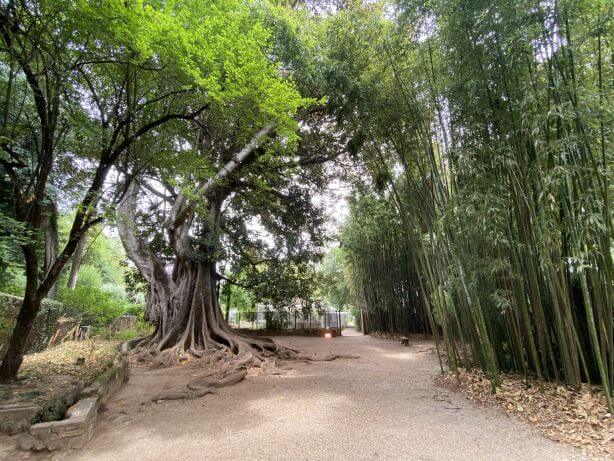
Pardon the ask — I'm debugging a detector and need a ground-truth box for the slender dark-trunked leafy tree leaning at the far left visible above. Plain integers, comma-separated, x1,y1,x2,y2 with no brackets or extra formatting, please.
0,0,211,381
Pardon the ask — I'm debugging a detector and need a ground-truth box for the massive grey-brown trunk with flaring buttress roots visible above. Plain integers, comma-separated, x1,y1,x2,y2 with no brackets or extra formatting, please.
118,183,293,373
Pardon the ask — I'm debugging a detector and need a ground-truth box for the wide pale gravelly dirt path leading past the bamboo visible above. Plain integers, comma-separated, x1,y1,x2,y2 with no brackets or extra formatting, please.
67,336,583,461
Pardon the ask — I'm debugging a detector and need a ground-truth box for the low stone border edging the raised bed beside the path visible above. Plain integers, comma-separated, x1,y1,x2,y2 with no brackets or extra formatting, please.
18,343,128,450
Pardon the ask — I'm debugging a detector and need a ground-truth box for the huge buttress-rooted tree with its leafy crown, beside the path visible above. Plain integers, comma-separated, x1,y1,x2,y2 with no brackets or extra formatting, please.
118,2,346,370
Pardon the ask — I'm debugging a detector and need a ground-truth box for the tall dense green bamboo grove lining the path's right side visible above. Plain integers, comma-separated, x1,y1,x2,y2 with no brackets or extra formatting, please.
328,0,614,407
